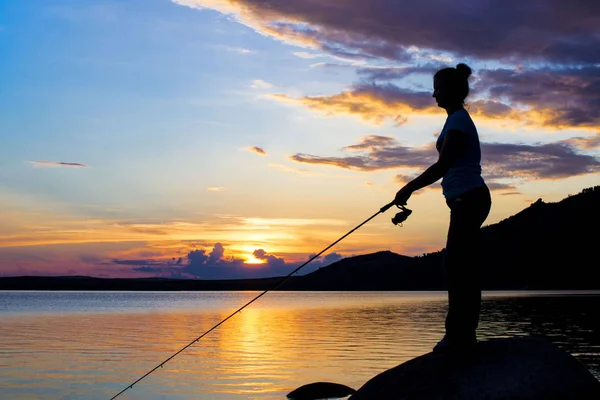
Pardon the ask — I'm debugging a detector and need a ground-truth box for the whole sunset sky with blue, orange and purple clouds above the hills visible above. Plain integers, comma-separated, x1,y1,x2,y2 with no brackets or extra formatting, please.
0,0,600,279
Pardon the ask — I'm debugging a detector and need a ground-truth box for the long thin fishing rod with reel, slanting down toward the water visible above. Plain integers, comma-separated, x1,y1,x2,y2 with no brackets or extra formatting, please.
110,201,412,400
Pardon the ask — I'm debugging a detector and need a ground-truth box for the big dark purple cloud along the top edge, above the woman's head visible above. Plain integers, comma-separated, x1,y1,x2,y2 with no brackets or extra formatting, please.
178,0,600,64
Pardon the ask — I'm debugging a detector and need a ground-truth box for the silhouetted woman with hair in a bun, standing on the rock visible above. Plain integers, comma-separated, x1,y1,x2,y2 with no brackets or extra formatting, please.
394,63,492,352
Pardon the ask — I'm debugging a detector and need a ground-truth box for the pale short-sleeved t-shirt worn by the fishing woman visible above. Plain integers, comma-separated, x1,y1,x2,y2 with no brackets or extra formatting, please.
436,109,485,199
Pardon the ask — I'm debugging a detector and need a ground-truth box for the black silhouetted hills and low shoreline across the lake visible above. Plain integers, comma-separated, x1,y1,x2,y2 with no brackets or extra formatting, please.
0,186,600,290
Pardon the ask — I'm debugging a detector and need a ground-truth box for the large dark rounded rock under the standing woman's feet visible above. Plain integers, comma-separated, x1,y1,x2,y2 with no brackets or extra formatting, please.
349,338,600,400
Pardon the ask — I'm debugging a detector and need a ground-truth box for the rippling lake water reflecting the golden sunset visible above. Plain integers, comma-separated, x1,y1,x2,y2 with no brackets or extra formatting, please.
0,292,600,400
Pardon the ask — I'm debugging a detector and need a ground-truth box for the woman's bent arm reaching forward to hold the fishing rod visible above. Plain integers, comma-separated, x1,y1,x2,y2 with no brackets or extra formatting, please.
394,129,465,205
